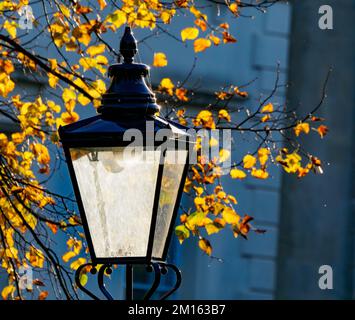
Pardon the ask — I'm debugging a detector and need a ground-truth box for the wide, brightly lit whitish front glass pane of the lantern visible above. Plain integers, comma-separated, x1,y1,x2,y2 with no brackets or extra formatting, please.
70,148,160,258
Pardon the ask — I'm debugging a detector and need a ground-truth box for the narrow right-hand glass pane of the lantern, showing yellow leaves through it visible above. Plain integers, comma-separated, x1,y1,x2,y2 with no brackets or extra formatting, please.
153,150,187,258
